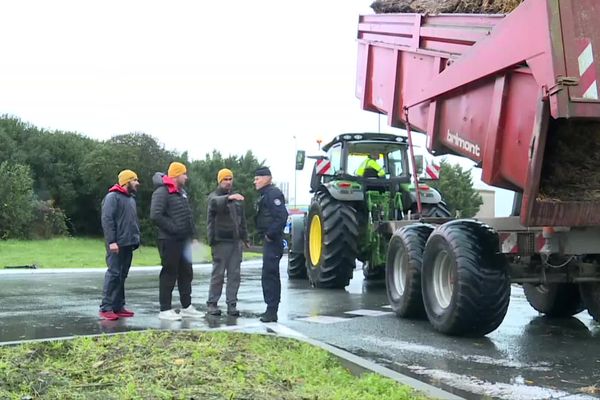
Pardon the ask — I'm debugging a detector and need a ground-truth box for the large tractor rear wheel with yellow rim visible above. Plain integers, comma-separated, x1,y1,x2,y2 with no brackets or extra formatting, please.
304,193,358,288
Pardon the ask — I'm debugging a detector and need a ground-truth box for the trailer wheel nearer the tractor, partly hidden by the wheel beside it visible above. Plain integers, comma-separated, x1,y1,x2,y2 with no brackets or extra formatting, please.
385,224,433,318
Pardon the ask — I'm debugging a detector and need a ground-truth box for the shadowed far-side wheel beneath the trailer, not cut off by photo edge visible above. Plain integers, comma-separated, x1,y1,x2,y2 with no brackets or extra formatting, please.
523,283,584,318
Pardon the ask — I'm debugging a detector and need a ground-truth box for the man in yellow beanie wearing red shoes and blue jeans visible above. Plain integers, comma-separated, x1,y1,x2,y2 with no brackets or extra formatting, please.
100,169,140,321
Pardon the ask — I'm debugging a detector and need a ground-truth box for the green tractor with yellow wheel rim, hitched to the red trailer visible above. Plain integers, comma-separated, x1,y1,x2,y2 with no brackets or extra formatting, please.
288,133,450,288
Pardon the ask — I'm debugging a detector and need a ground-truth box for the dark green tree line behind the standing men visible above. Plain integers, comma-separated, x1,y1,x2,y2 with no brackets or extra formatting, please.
0,115,263,244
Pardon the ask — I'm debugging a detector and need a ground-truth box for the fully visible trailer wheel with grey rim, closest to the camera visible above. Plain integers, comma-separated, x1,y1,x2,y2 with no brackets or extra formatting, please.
421,220,510,336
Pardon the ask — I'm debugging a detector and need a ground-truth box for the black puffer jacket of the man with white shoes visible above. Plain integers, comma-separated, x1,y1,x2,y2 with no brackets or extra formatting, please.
150,172,196,240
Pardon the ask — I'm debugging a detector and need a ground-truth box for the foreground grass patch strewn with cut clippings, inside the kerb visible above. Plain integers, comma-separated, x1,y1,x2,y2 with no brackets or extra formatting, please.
0,331,426,400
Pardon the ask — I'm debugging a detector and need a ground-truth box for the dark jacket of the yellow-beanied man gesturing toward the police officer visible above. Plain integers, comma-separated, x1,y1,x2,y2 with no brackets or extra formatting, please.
206,187,248,246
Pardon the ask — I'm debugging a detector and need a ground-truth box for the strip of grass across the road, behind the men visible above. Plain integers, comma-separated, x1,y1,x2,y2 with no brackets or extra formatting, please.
0,238,260,268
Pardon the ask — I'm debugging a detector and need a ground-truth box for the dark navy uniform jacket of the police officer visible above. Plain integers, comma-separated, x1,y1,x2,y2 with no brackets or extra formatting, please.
256,185,288,240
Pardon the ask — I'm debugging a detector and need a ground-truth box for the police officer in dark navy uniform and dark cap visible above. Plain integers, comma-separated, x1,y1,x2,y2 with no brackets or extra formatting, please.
254,167,288,322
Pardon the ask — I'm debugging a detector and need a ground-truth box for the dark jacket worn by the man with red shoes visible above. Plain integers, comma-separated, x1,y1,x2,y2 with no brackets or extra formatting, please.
102,185,140,247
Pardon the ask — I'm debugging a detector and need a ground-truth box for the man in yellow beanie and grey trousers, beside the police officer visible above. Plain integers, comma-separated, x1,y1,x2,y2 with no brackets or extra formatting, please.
206,168,248,317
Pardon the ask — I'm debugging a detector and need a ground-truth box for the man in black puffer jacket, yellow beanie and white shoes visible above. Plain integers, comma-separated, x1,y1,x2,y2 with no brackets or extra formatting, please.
150,162,202,320
